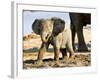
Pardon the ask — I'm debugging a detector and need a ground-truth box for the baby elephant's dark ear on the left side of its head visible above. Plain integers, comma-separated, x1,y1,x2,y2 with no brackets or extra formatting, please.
32,19,41,35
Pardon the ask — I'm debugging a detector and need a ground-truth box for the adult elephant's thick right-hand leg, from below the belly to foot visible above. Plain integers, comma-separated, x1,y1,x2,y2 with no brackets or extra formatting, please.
76,25,88,52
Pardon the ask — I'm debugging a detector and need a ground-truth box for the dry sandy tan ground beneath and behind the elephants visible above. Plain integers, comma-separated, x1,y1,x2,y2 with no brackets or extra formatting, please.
23,27,91,69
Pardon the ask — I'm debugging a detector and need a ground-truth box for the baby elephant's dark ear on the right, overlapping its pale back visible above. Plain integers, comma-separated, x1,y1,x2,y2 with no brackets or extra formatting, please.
51,17,65,36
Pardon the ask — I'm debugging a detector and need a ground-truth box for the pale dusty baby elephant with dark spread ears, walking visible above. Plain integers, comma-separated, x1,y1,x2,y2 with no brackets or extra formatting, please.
32,17,74,65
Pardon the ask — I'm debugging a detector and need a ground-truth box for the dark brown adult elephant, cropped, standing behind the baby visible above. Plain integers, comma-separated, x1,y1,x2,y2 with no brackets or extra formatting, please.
69,13,91,52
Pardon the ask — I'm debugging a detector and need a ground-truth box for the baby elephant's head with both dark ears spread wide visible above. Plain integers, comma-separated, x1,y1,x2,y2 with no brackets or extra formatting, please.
32,17,65,42
